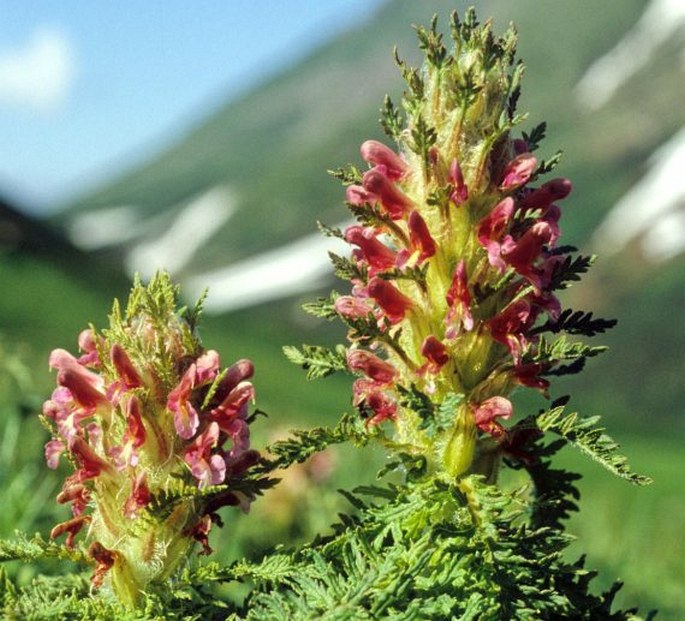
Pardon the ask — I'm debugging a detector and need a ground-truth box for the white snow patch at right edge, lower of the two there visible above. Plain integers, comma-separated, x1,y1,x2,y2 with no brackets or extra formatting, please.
592,128,685,262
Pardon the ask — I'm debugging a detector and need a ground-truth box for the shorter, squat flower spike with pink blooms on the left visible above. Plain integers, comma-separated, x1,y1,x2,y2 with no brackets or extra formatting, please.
43,274,258,602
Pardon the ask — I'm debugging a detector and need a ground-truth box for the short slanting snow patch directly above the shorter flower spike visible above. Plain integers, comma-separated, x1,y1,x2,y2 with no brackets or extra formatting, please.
125,186,235,278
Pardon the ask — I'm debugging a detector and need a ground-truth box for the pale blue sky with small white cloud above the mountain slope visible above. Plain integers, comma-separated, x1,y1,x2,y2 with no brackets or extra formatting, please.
0,0,382,212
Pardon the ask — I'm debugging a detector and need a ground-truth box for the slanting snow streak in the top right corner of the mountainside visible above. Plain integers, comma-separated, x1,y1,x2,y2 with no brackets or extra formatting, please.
576,0,685,110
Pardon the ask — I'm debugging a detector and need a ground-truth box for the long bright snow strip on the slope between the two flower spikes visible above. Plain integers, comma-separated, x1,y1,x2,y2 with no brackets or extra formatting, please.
183,223,350,313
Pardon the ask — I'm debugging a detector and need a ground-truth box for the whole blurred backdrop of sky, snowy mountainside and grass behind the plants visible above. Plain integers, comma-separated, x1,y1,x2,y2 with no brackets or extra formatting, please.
0,0,685,619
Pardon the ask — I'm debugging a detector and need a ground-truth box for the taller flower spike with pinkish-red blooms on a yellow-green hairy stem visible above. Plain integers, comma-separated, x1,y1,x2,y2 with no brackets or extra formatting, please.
332,14,582,477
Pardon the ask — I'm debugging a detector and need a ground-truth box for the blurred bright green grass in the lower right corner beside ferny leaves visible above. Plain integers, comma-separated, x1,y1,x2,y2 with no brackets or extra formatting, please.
560,430,685,621
